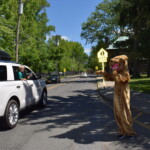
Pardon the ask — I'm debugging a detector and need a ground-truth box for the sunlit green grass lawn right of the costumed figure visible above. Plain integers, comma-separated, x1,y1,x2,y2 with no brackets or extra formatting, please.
130,76,150,94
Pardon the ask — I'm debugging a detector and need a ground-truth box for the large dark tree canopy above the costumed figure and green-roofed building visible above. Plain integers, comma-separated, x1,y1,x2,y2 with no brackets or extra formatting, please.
81,0,150,75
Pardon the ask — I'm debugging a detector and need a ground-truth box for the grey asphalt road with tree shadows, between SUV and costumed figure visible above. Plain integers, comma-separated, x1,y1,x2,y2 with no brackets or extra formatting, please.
0,76,150,150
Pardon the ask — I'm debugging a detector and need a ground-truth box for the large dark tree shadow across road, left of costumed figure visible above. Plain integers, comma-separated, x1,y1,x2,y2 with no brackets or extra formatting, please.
19,90,116,144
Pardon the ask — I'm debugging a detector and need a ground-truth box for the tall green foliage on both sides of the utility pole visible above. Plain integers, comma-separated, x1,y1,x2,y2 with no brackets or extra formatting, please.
0,0,54,72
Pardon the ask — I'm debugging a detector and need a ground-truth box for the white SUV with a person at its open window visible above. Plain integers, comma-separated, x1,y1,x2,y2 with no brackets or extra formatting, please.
0,61,47,129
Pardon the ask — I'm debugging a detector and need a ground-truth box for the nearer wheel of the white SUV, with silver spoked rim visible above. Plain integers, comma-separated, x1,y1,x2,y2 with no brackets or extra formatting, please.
4,100,19,129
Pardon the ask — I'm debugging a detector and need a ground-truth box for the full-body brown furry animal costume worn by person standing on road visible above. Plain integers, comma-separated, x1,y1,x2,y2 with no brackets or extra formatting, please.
97,55,135,136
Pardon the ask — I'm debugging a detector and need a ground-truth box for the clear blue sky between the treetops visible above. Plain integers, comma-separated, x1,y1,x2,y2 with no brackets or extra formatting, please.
47,0,101,55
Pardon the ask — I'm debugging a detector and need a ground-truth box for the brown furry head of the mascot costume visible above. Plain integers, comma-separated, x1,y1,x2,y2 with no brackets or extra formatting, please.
110,55,128,71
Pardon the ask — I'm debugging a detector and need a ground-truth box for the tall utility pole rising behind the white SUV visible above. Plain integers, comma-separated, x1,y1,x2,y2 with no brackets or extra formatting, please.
15,0,23,62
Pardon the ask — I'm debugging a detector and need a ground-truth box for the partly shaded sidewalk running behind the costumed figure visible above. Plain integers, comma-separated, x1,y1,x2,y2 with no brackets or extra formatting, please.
96,77,150,114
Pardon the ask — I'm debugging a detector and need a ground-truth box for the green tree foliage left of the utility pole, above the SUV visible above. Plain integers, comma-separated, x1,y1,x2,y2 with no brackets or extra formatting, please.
0,0,17,58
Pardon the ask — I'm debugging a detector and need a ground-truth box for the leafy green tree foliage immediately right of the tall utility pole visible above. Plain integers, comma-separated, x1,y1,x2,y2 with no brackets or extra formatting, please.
20,0,54,72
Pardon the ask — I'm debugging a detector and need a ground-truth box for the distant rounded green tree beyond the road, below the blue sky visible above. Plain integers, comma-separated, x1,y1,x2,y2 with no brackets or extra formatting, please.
48,38,88,71
